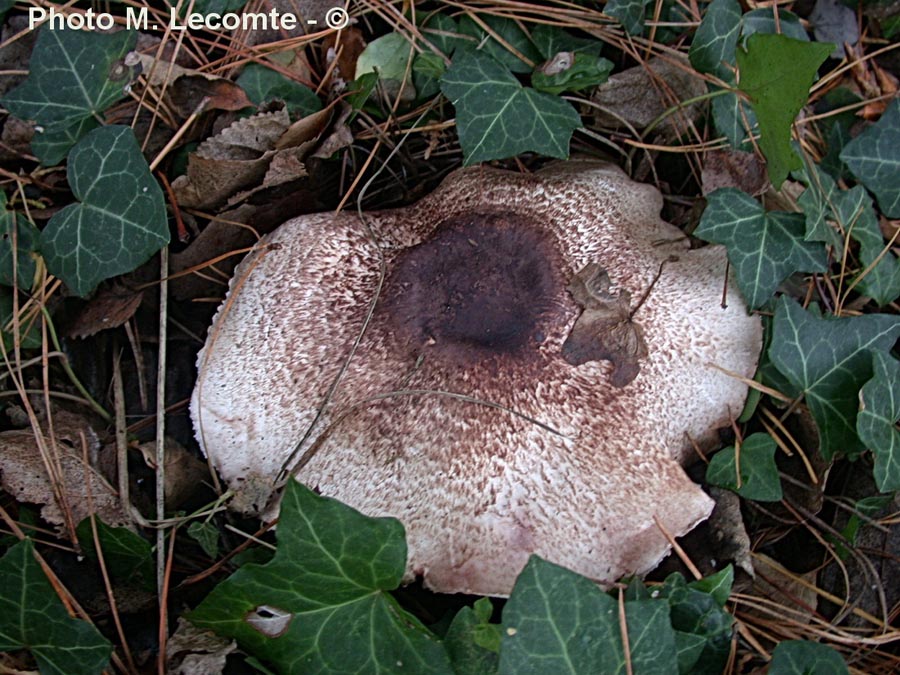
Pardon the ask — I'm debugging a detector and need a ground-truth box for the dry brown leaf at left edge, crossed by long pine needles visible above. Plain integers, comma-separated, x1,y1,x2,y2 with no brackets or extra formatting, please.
0,411,131,533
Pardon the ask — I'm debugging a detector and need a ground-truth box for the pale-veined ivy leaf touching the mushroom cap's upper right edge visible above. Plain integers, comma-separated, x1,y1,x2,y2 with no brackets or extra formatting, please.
694,188,826,309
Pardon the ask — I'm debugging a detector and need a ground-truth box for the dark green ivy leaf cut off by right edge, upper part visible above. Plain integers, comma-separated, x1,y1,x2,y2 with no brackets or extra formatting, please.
841,100,900,218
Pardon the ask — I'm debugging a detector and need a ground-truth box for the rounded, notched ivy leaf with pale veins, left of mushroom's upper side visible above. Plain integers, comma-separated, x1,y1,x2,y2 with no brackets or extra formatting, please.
40,126,169,297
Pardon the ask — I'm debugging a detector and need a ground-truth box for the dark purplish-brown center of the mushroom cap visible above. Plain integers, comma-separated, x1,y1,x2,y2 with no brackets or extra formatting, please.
382,212,566,365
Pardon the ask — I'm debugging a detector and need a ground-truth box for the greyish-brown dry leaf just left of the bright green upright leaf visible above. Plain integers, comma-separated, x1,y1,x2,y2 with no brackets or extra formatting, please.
591,56,706,138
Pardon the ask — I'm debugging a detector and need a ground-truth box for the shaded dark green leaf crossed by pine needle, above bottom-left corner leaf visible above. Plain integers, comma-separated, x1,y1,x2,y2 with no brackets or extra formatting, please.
75,518,156,590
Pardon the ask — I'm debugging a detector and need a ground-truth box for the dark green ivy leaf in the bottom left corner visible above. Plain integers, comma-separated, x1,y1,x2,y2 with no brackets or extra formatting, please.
0,539,112,675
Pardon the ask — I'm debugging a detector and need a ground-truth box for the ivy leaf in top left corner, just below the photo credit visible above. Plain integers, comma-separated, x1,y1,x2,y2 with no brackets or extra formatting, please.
2,28,137,162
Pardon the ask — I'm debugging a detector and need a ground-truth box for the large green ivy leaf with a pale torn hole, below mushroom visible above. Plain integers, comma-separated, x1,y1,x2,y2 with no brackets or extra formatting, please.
188,481,452,675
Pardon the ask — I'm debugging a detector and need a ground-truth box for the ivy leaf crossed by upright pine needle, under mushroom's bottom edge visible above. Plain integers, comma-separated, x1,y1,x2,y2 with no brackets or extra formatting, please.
500,556,677,675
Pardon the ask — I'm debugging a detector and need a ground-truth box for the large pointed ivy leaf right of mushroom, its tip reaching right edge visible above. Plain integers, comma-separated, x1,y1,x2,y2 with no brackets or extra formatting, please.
768,297,900,459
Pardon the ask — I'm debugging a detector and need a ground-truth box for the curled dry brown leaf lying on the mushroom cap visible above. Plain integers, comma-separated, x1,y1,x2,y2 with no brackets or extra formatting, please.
562,263,647,387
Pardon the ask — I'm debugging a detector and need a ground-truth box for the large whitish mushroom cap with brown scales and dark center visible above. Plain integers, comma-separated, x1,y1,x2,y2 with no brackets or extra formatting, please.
191,162,761,595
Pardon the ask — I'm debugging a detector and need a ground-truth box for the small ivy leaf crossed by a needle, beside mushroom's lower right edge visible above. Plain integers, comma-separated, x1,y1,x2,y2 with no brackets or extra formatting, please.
706,433,782,502
